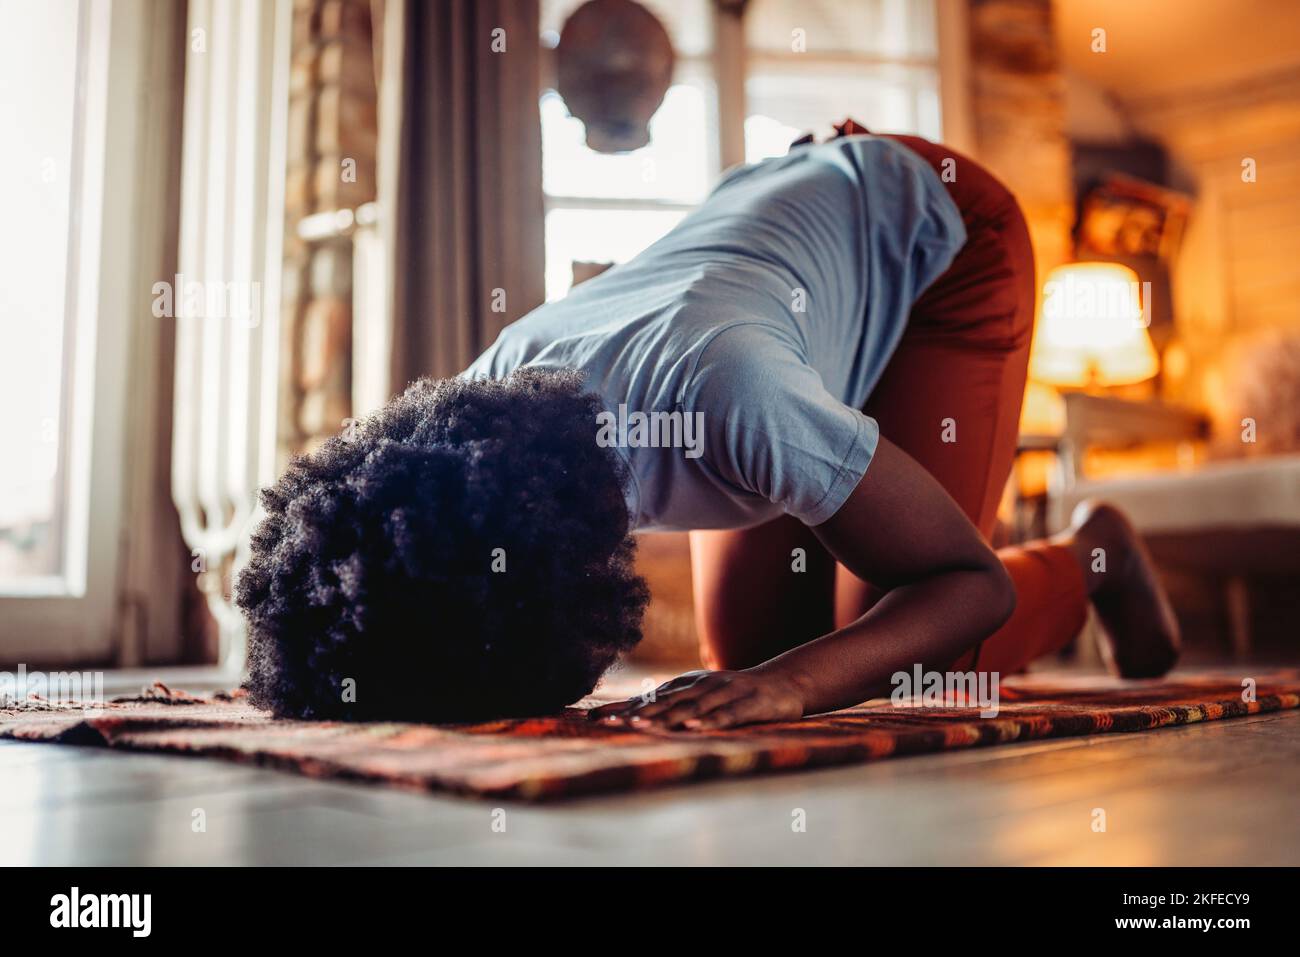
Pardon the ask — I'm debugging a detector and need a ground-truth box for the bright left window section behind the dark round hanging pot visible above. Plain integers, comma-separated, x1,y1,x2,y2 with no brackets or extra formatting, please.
541,0,719,300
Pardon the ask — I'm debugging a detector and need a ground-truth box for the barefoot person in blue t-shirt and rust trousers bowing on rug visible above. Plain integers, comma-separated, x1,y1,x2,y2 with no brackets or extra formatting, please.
238,121,1178,728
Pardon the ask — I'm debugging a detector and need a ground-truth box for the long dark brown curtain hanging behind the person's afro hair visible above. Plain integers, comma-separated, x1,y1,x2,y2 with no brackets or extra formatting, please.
387,0,545,389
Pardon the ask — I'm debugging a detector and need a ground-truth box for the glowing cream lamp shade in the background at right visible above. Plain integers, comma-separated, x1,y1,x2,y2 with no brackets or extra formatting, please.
1030,263,1160,387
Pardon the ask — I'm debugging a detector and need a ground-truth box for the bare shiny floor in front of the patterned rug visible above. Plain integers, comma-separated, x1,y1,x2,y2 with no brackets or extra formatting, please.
0,696,1300,865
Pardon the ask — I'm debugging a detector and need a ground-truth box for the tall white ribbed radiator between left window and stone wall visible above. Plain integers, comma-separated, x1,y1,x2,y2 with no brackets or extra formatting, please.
172,0,293,671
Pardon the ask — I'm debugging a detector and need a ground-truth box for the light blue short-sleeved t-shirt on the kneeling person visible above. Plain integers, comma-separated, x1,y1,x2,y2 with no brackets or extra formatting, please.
463,135,966,529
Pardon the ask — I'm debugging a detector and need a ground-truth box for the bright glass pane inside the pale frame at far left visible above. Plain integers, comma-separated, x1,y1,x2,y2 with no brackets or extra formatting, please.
0,0,107,596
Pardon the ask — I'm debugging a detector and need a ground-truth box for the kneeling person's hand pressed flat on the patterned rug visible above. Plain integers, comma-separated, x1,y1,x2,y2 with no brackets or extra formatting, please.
588,671,803,731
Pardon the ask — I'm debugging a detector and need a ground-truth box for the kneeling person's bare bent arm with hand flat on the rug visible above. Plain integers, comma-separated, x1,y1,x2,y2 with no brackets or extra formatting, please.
594,438,1015,728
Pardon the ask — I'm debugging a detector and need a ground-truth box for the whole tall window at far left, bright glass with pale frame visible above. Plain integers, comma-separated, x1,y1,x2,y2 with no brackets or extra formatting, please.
0,0,189,667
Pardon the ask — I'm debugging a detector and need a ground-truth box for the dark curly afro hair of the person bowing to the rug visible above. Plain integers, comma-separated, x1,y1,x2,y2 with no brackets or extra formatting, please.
235,369,649,722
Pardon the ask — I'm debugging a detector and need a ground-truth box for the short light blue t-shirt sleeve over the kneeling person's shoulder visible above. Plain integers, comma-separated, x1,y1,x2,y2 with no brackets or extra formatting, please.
683,322,880,525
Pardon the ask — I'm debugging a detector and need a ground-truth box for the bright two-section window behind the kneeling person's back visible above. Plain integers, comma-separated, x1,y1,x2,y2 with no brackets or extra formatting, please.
541,0,941,300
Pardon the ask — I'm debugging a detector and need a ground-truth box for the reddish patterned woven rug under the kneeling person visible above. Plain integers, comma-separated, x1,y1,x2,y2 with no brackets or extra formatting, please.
0,671,1300,801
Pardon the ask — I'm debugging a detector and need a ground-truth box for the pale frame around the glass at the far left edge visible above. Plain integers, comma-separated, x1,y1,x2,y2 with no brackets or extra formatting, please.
0,0,185,667
